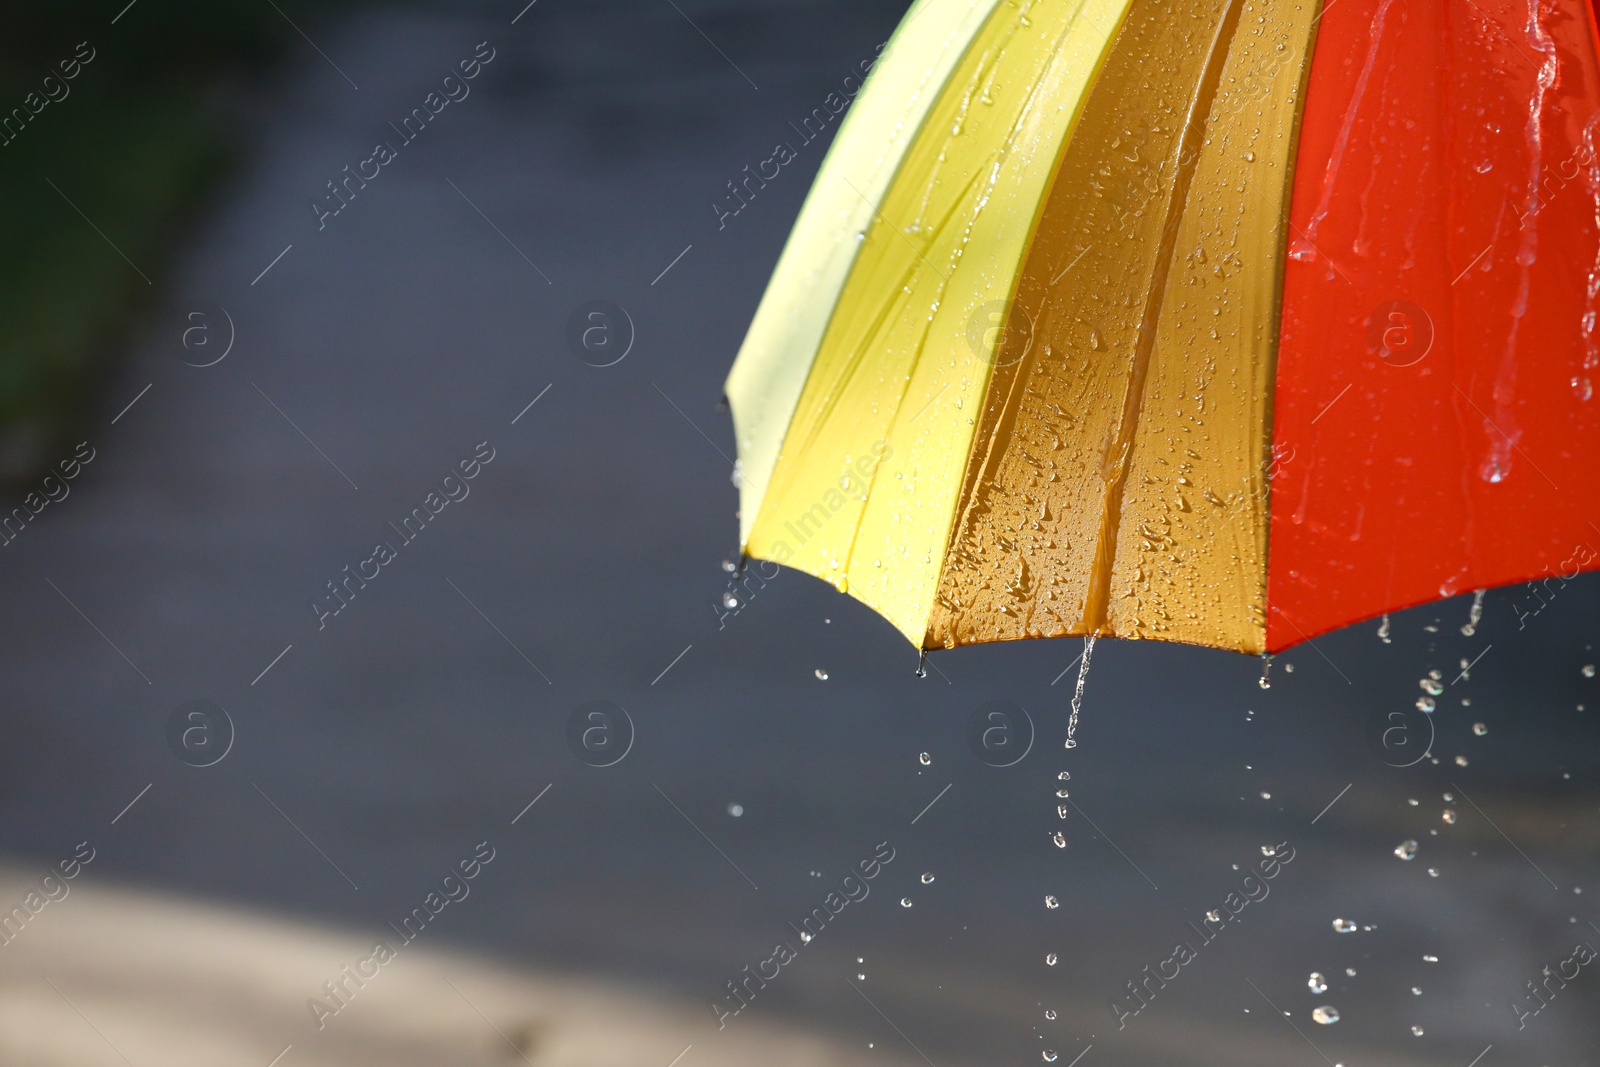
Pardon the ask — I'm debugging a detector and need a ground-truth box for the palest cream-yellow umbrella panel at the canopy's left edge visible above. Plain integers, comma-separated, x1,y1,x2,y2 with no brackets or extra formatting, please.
723,0,997,544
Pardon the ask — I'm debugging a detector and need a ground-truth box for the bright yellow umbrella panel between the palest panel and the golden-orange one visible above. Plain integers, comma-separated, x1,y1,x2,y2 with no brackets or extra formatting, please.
749,0,1126,643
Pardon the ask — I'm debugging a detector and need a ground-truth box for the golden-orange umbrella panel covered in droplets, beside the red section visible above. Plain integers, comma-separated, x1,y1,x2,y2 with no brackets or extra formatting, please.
925,0,1317,651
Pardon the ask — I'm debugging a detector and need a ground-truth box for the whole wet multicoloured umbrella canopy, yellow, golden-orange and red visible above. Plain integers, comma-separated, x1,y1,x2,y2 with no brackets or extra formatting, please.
728,0,1600,653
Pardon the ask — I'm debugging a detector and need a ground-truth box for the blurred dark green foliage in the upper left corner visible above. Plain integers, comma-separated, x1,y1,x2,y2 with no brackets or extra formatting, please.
0,0,348,483
